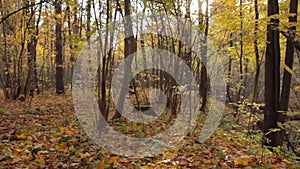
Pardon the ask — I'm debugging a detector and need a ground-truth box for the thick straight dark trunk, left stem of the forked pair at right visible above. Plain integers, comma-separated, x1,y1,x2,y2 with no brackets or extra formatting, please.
264,0,280,147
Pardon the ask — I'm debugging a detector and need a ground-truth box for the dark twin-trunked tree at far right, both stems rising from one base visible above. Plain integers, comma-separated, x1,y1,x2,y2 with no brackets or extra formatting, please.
264,0,298,147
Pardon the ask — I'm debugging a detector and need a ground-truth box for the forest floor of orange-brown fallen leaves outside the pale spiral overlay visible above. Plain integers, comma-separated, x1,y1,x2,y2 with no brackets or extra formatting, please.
0,95,300,169
